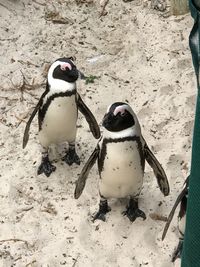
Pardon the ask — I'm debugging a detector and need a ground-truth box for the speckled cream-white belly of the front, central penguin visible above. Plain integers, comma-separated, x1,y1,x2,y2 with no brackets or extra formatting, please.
99,141,144,198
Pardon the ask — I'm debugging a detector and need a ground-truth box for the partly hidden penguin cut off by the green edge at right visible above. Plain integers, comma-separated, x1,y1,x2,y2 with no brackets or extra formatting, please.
162,176,189,262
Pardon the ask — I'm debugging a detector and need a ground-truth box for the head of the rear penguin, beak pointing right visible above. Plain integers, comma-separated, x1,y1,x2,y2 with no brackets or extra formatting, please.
48,57,84,83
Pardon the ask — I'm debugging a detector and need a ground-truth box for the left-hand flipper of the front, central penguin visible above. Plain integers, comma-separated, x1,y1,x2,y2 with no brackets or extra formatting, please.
74,145,100,199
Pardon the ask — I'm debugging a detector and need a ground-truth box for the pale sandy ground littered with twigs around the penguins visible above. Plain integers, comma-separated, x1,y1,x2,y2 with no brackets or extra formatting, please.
0,0,196,267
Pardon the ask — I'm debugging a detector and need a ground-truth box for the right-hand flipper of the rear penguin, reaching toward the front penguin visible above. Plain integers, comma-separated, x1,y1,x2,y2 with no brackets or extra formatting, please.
76,93,101,139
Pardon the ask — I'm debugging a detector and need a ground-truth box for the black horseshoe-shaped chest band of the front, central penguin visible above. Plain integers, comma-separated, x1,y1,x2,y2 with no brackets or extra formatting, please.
98,136,145,173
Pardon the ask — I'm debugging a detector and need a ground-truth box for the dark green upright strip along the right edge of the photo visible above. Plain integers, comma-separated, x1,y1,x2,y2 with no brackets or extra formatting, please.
181,0,200,267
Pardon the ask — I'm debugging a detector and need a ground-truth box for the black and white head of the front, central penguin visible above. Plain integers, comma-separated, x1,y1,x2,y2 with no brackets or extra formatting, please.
102,102,140,135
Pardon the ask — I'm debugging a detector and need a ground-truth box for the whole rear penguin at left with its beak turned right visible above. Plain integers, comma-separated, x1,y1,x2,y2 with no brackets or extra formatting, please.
23,57,100,177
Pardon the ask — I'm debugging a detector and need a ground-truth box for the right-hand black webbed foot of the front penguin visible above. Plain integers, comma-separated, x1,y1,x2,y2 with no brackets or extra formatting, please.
122,198,146,222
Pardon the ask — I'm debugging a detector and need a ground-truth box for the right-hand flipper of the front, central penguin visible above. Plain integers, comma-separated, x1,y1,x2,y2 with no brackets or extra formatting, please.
144,142,170,196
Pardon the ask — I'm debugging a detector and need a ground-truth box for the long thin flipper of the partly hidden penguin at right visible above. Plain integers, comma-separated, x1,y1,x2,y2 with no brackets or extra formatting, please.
162,176,190,240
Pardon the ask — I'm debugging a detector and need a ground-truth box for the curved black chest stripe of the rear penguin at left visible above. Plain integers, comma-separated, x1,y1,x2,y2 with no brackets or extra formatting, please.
38,89,76,130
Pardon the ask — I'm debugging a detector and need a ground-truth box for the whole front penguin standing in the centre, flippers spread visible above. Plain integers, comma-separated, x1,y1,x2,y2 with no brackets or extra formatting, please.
74,102,169,222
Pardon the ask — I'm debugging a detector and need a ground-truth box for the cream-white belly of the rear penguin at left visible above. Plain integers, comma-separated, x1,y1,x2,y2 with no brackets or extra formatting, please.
39,95,77,147
